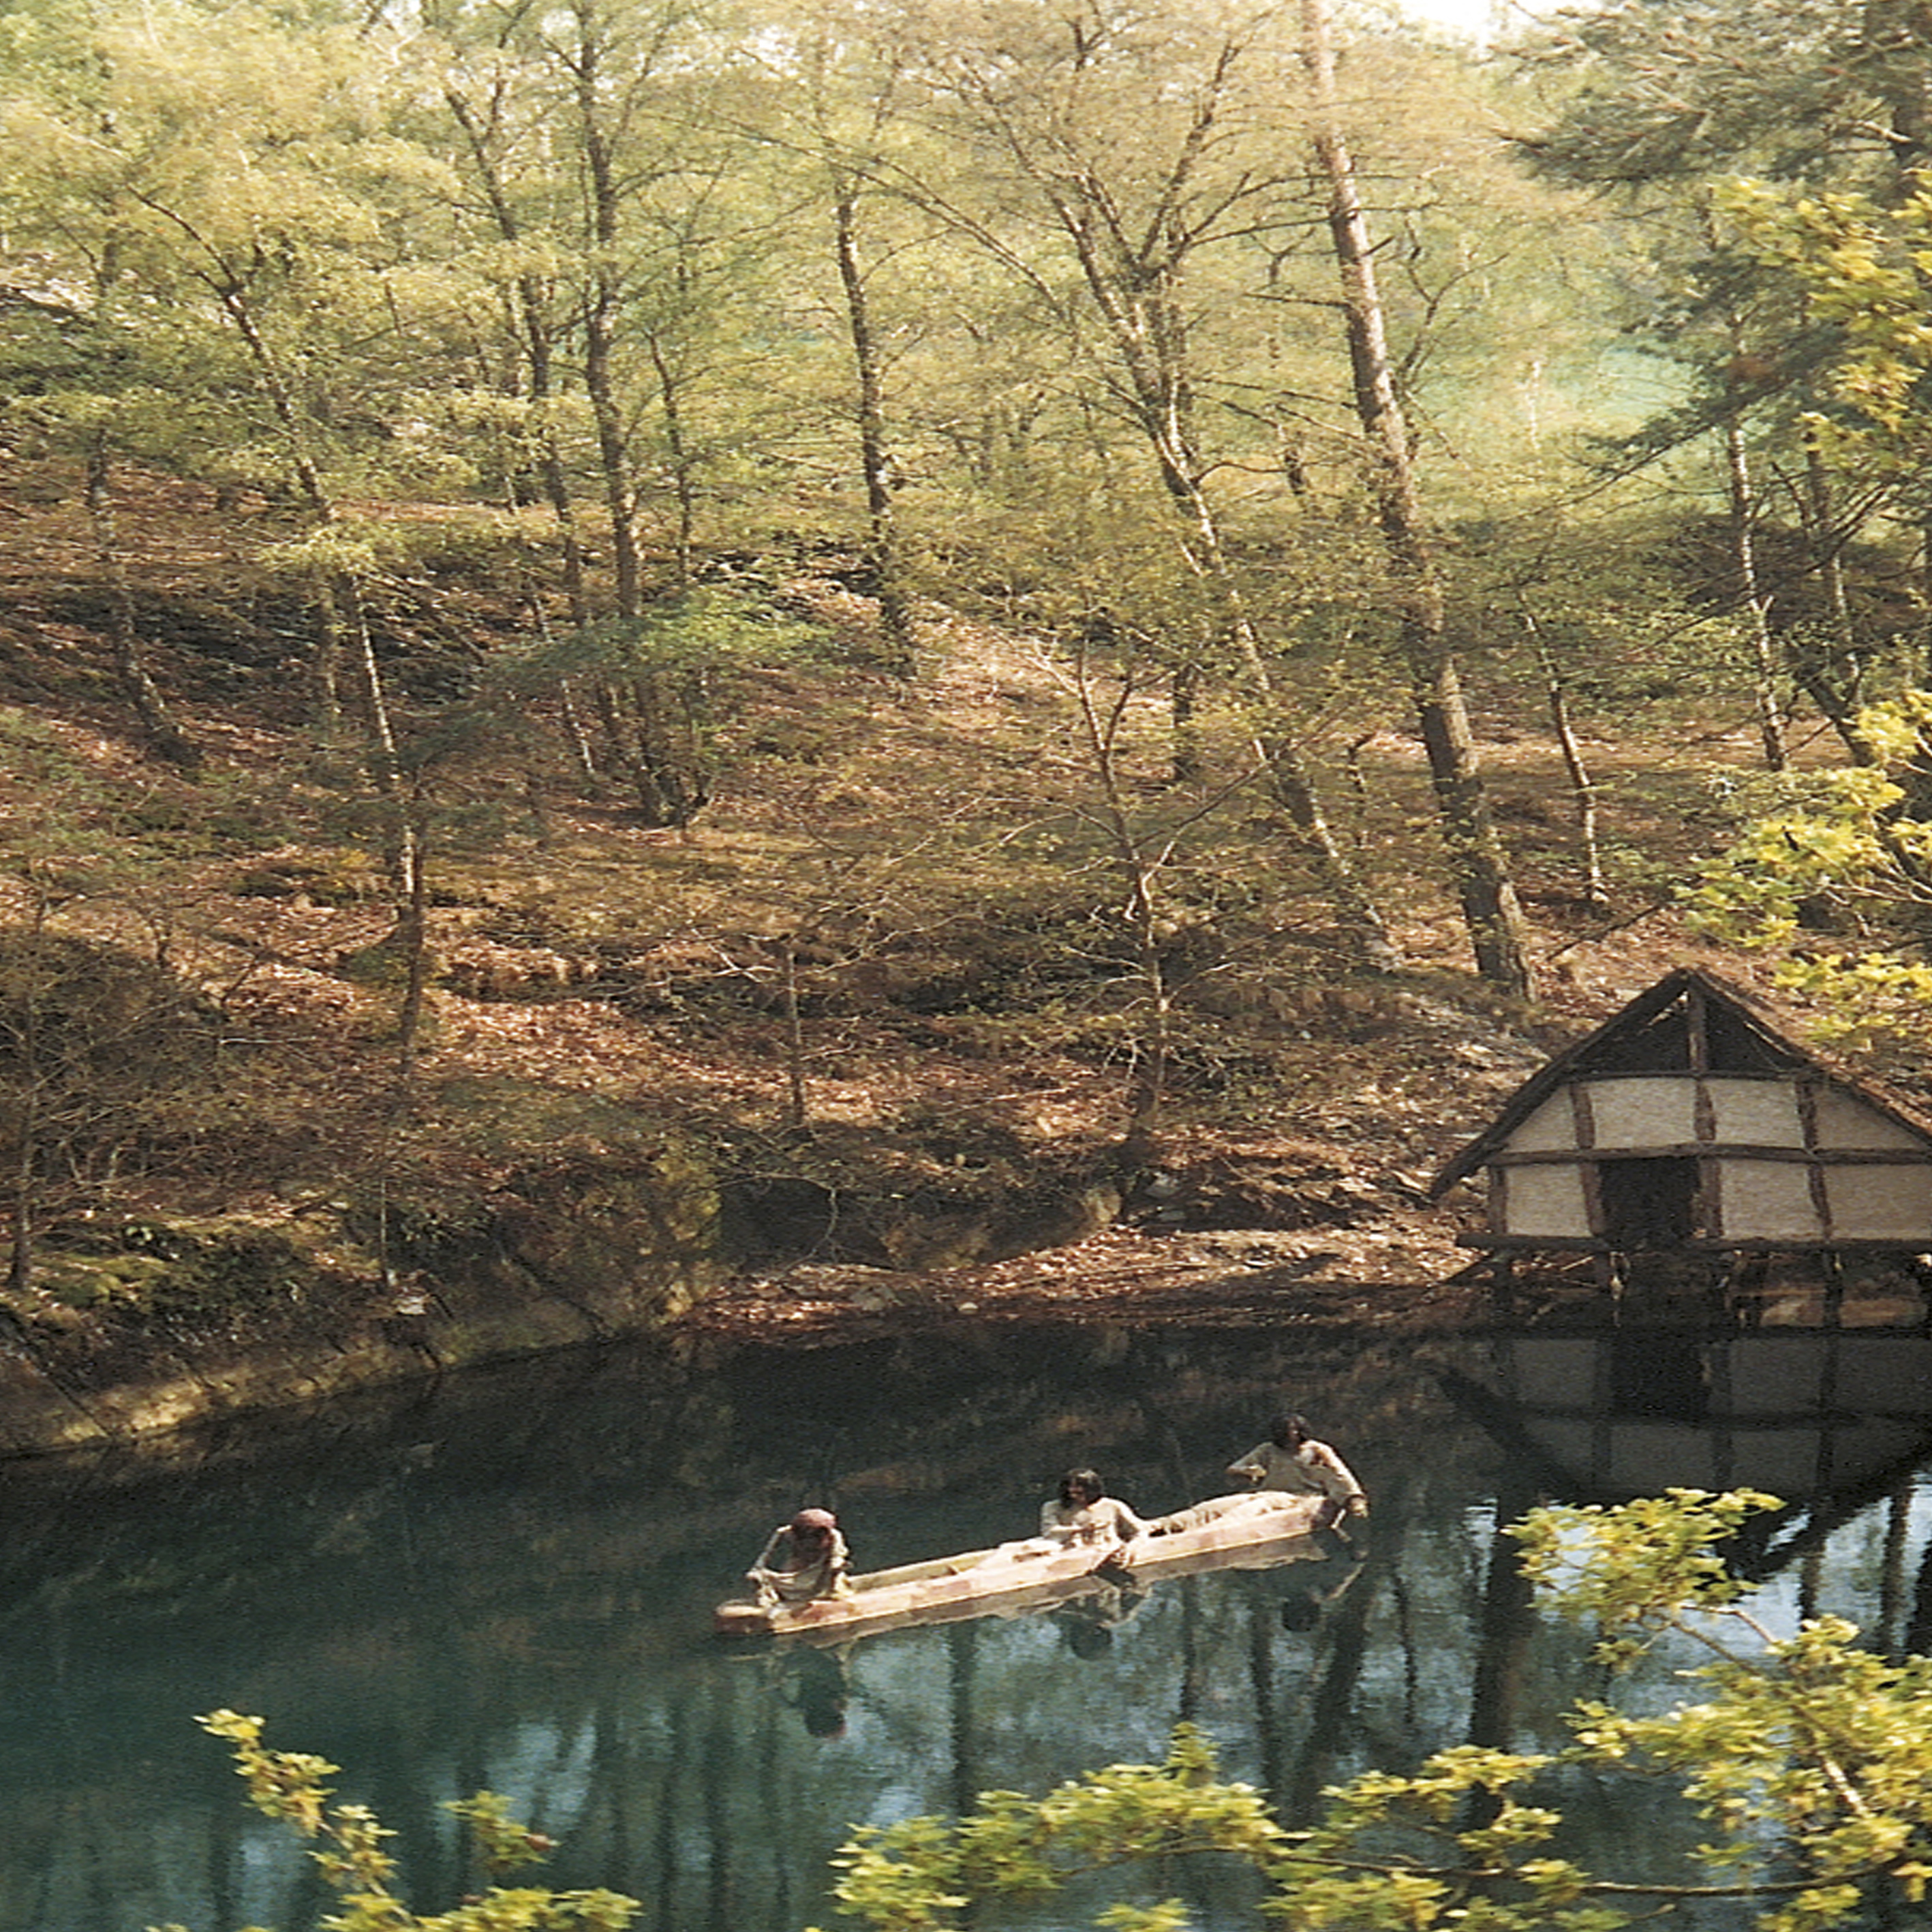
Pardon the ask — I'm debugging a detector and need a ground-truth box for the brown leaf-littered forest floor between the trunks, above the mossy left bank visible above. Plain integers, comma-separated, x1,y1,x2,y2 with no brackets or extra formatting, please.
0,454,1854,1368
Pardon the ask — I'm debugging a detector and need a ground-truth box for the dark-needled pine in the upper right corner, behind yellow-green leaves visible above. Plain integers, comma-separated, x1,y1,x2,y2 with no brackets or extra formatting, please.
1518,0,1932,746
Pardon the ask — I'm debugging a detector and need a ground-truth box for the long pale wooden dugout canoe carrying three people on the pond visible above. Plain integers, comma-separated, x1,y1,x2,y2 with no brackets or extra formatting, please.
713,1492,1337,1642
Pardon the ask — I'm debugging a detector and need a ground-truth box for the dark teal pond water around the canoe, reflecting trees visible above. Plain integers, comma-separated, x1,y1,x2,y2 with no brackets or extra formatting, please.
0,1328,1932,1932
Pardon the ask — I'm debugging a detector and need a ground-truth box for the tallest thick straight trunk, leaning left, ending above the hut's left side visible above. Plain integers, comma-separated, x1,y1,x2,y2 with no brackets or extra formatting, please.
1300,0,1536,999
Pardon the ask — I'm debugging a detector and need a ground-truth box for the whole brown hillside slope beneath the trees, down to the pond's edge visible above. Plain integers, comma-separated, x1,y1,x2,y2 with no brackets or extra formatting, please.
0,465,1824,1414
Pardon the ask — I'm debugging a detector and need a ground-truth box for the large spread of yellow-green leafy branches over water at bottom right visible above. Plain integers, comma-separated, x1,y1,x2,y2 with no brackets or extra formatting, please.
808,1490,1932,1932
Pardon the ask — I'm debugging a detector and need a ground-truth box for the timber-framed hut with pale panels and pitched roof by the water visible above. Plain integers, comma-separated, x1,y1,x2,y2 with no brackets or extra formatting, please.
1432,968,1932,1325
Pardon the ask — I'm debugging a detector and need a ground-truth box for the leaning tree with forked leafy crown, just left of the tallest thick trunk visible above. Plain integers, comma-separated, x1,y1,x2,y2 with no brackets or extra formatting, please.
877,4,1399,970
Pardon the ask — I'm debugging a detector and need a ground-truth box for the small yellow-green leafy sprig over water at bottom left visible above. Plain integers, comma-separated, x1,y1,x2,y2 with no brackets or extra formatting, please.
197,1710,638,1932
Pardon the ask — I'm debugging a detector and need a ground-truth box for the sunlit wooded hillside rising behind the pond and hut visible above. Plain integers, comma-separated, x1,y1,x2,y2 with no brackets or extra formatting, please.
0,0,1932,1391
